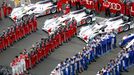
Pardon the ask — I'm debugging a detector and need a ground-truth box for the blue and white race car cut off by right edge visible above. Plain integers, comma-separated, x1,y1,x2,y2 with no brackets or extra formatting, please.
119,33,134,47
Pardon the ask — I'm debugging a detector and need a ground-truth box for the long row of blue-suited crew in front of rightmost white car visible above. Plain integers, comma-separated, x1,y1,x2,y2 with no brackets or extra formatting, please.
51,32,116,75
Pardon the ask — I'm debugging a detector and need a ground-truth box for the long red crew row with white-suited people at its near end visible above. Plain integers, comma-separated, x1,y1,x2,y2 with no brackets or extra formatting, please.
10,18,77,75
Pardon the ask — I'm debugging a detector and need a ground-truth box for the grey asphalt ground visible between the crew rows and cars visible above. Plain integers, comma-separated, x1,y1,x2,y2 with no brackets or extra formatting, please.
0,0,134,75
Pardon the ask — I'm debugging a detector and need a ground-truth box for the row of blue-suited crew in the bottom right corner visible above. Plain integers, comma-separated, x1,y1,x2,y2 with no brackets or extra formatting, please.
96,43,134,75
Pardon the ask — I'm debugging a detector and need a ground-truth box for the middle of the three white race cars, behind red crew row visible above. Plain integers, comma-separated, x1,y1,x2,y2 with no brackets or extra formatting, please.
42,9,96,34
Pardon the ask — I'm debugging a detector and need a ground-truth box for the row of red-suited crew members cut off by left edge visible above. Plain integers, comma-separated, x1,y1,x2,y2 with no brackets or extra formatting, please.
0,17,37,52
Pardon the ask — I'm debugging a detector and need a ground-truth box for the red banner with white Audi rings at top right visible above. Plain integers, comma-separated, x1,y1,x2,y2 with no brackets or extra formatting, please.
82,0,134,16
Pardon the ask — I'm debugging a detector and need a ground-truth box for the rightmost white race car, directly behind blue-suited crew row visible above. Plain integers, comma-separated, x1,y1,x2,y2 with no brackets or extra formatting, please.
78,15,134,43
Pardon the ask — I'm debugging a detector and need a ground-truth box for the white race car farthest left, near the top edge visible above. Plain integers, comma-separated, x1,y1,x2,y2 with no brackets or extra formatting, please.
9,0,57,20
